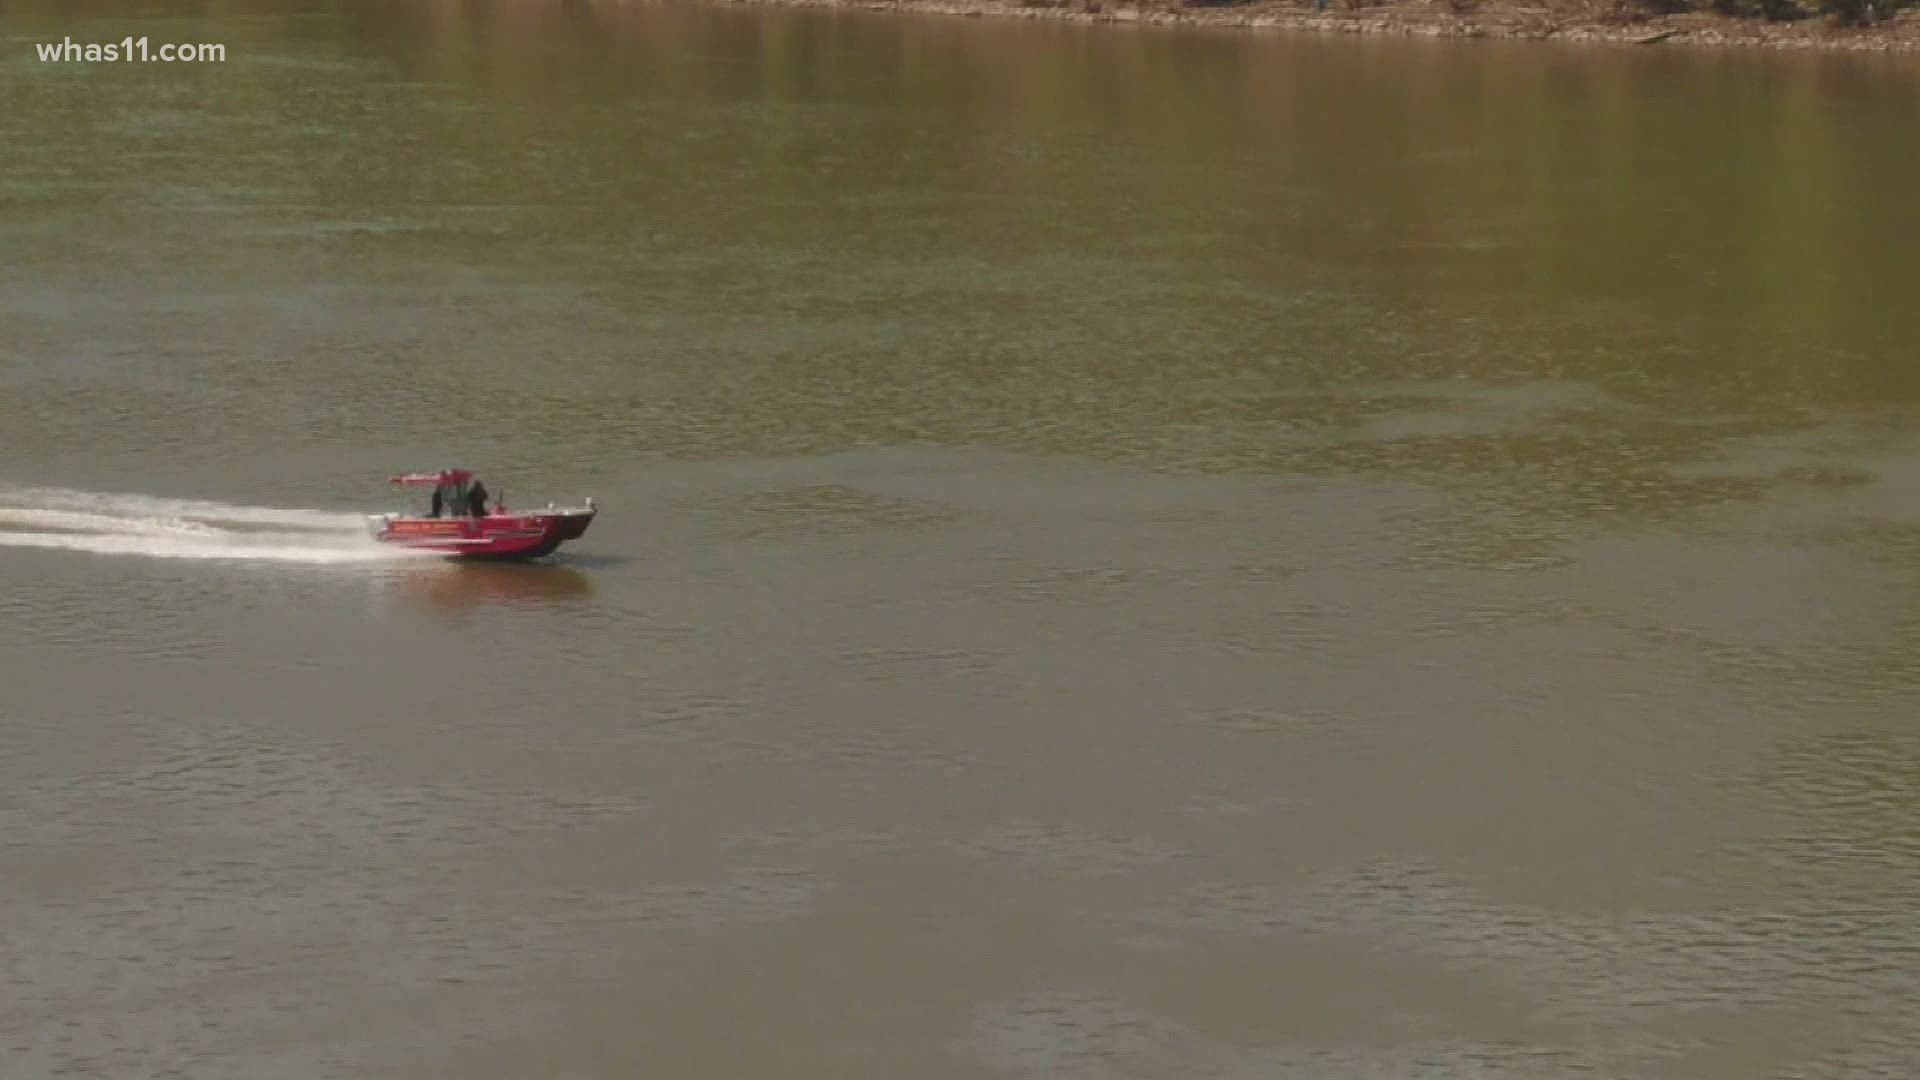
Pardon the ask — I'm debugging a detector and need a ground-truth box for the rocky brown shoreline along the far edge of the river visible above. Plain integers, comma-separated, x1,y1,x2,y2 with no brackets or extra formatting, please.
710,0,1920,52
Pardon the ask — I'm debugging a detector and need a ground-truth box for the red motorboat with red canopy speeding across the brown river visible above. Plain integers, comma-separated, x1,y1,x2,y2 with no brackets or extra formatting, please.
367,469,599,559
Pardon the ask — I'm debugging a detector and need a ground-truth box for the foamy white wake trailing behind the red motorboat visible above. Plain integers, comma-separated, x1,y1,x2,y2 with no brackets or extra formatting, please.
0,486,420,563
